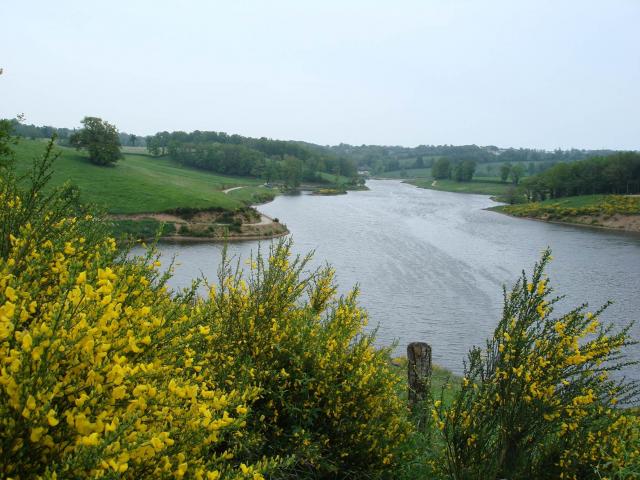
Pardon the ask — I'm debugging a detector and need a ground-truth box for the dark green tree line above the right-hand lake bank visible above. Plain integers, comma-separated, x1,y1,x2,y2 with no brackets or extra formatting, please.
523,152,640,200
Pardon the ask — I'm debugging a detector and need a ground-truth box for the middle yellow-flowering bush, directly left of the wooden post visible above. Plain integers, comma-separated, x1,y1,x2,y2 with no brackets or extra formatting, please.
189,241,410,478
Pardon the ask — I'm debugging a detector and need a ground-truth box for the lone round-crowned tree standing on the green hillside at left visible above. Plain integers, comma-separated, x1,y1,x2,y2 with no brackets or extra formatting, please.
69,117,122,165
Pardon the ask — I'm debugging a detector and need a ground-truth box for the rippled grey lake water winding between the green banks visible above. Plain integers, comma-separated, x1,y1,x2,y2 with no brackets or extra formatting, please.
144,180,640,378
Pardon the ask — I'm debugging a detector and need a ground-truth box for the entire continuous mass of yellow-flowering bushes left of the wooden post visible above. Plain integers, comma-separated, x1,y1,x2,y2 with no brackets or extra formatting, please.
0,133,410,480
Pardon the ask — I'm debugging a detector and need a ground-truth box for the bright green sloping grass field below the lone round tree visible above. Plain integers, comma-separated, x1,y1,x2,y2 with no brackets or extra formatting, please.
15,139,274,213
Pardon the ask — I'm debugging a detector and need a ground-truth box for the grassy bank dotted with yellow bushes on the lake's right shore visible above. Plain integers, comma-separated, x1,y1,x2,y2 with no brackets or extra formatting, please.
492,195,640,232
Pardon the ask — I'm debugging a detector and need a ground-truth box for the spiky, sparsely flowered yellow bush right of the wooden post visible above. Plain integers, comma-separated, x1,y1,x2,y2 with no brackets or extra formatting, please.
432,252,640,479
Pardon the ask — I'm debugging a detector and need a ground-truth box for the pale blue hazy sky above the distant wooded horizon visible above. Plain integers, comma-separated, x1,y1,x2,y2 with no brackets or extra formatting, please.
0,0,640,150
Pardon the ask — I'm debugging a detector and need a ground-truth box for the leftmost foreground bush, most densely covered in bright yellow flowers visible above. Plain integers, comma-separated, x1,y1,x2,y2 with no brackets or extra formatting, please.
0,139,280,479
